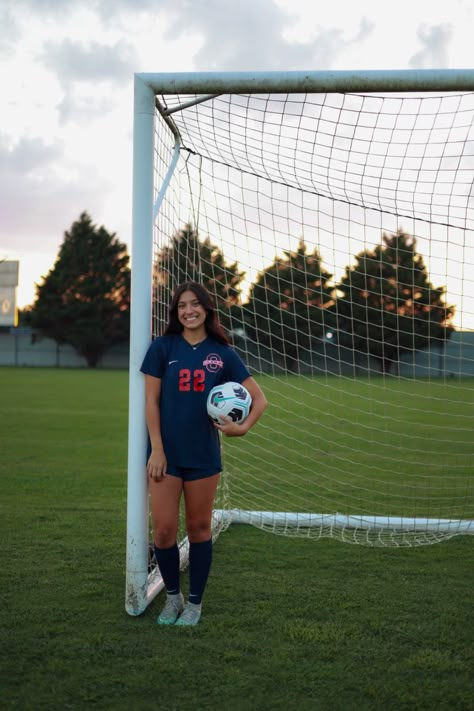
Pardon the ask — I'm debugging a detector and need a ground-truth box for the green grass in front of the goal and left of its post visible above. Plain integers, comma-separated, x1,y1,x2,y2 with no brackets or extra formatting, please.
0,368,474,711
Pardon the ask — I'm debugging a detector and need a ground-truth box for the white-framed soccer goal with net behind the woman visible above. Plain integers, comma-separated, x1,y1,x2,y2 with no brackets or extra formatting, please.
126,70,474,614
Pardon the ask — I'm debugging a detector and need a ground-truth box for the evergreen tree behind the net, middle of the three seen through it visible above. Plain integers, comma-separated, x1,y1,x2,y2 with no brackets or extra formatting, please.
246,241,333,370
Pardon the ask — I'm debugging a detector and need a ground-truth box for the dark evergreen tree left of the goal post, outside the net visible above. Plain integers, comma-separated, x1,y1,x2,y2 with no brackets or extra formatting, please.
28,212,130,367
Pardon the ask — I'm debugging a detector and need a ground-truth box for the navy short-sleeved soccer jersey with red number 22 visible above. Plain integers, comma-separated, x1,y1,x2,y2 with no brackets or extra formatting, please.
140,335,250,473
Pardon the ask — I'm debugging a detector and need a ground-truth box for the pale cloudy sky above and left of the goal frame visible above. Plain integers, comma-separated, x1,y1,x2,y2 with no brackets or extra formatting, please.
0,0,474,326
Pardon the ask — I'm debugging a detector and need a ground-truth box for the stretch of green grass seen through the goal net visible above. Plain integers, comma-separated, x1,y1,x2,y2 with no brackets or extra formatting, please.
225,376,474,519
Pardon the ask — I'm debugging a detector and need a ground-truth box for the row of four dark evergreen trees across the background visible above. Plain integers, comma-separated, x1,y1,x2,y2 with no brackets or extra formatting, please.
21,212,455,373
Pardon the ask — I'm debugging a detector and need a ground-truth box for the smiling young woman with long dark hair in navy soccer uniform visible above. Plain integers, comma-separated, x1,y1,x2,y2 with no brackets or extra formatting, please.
141,282,267,625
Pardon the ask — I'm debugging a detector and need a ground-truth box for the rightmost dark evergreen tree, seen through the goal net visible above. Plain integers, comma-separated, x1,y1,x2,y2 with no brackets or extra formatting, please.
337,230,454,373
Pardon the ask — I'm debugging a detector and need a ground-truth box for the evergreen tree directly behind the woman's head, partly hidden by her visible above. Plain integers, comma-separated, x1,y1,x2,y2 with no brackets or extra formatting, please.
154,224,245,331
